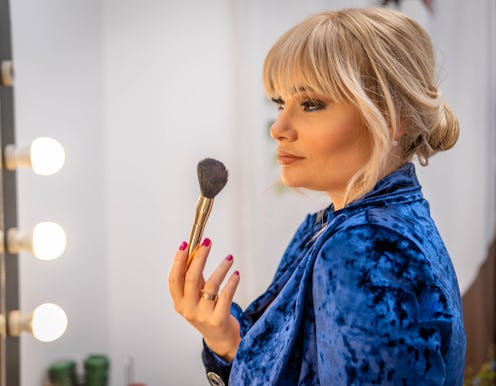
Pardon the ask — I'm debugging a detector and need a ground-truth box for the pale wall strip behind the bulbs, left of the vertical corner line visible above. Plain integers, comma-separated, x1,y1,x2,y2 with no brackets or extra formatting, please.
10,0,109,386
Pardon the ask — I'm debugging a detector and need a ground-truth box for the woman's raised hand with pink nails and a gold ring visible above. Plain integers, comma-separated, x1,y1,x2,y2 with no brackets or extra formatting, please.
169,239,241,361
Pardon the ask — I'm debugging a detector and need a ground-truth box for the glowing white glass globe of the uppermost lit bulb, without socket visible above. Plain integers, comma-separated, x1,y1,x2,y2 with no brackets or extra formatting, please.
30,137,65,176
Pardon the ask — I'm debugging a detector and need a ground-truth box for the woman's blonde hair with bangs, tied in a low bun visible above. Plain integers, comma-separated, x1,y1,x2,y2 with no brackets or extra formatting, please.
263,8,459,204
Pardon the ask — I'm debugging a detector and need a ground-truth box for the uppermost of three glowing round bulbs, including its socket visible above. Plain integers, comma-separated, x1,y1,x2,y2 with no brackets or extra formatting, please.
5,137,65,176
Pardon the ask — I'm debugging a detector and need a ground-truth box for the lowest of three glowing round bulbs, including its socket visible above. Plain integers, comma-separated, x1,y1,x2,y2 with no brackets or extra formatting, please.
8,303,67,342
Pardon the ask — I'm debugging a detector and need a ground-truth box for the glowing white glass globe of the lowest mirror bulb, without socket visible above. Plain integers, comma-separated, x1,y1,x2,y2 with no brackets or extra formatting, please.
31,303,67,342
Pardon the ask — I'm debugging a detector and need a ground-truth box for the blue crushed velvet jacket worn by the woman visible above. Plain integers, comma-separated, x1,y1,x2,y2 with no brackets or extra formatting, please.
203,163,465,386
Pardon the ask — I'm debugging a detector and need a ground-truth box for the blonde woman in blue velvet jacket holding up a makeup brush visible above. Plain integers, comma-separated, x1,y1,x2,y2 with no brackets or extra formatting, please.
169,8,465,386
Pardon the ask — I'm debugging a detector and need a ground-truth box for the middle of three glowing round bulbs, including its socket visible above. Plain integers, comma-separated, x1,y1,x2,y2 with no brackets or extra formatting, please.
7,221,67,260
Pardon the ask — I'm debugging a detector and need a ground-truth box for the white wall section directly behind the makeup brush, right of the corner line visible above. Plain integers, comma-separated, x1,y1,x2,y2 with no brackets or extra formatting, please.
103,0,235,385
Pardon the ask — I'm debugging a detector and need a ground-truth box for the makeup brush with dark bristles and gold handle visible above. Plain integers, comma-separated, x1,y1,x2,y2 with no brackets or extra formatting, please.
186,158,228,267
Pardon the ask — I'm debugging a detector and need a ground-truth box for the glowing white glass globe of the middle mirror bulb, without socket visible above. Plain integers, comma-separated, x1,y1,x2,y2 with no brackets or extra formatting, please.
32,221,67,260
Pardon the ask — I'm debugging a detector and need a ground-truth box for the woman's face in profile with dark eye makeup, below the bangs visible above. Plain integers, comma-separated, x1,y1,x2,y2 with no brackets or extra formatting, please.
270,92,371,209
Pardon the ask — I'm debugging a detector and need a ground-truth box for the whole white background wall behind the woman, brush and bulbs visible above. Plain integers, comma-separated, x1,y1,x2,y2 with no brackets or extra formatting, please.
11,0,494,386
